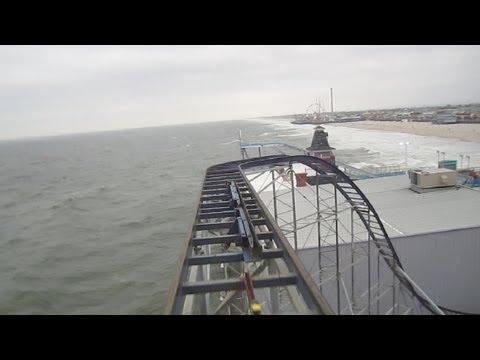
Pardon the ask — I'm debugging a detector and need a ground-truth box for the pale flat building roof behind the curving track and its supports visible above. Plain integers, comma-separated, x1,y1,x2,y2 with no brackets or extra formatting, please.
254,173,480,248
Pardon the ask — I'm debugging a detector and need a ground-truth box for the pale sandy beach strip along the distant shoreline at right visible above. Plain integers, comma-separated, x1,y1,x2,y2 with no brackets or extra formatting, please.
330,121,480,142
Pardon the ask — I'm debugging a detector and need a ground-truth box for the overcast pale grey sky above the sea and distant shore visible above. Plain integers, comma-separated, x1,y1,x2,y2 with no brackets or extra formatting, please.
0,46,480,139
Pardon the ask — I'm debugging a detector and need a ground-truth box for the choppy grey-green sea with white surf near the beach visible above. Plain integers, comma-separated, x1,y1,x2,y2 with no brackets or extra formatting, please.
0,119,480,314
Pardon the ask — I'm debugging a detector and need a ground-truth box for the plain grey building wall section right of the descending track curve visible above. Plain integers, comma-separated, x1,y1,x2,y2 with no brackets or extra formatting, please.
392,227,480,313
